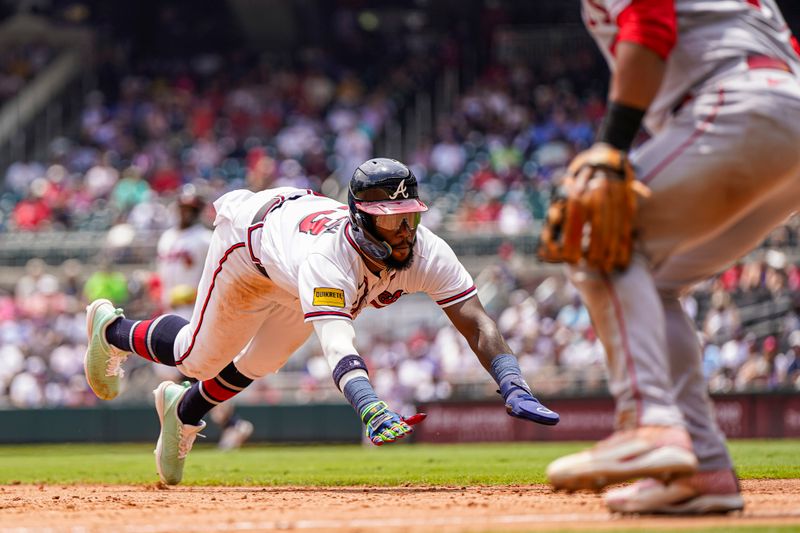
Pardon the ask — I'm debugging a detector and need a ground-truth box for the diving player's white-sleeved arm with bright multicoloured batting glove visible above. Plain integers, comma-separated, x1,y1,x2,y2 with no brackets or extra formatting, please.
314,319,425,446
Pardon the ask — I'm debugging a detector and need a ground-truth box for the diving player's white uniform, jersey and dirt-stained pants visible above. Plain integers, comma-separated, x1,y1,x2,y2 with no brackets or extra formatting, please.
174,187,476,379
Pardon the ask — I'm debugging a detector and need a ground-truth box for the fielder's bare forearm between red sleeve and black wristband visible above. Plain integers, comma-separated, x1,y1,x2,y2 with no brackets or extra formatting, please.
608,41,666,110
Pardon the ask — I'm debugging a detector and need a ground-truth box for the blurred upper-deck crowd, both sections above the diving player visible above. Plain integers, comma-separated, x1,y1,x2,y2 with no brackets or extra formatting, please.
0,41,604,234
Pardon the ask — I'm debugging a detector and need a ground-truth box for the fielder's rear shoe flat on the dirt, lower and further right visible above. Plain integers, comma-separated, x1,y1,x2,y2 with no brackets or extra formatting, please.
603,470,744,515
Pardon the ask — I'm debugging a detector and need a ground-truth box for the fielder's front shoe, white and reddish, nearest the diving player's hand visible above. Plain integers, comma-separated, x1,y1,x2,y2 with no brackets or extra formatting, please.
547,426,697,491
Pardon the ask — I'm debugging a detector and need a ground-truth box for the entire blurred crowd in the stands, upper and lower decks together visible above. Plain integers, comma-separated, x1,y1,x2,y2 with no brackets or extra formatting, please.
0,7,800,407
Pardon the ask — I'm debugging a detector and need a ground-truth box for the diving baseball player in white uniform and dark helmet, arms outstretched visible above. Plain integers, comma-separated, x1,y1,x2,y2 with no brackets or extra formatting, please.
85,159,559,484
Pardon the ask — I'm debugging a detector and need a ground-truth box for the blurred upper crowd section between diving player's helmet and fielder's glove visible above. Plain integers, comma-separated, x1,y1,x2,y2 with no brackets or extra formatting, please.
408,52,605,235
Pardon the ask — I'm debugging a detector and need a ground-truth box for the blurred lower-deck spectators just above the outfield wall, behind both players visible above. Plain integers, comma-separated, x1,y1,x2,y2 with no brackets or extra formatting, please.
0,239,800,407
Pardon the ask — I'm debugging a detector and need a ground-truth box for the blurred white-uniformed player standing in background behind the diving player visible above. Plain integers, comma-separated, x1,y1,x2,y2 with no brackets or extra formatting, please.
157,185,253,450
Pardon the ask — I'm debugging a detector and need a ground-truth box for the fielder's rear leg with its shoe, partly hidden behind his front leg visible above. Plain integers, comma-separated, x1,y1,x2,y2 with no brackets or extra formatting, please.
605,170,800,514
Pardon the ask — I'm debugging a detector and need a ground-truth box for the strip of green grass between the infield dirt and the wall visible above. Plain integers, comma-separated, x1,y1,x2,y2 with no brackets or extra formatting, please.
0,440,800,486
